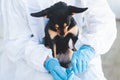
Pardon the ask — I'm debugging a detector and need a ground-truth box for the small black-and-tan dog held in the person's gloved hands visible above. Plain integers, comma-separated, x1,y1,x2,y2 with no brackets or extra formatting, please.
31,2,87,68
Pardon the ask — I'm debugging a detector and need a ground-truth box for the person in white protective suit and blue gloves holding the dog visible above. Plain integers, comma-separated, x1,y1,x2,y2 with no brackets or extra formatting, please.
0,0,116,80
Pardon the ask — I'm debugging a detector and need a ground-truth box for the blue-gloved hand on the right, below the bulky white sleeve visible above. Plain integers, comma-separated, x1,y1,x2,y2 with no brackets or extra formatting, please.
72,45,95,73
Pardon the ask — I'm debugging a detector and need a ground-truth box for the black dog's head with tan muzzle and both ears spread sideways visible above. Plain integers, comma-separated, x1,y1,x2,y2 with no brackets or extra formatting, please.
31,2,87,36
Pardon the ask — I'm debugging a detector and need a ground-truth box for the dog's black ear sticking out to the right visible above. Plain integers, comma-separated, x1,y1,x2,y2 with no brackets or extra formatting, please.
68,6,88,14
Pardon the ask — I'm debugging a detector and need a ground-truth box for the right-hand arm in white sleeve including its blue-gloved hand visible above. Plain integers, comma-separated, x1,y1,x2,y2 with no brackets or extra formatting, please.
72,0,116,73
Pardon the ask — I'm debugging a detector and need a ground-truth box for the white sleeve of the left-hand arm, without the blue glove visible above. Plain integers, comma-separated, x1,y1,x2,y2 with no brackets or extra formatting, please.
1,0,52,71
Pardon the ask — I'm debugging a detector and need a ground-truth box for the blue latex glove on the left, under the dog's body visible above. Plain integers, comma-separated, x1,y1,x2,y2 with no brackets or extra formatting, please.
45,58,67,80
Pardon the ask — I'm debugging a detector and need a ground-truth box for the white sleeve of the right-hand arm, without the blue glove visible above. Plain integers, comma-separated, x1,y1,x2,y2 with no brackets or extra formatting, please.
75,0,117,54
